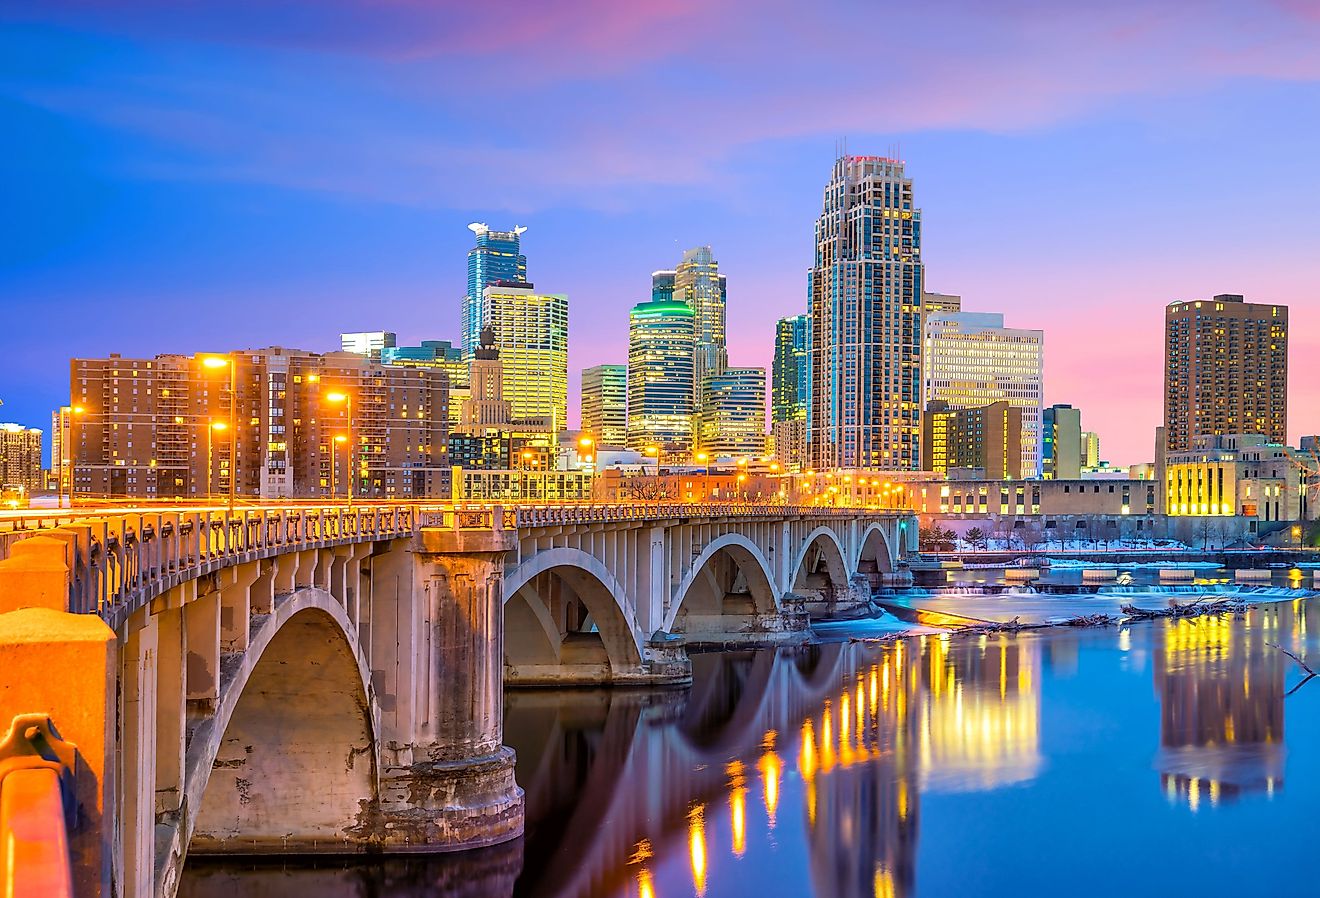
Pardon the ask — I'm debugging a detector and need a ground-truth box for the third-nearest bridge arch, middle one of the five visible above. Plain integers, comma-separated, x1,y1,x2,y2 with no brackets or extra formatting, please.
664,534,780,633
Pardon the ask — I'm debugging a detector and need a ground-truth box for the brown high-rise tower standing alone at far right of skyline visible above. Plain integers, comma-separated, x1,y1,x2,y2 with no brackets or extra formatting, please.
1164,293,1288,452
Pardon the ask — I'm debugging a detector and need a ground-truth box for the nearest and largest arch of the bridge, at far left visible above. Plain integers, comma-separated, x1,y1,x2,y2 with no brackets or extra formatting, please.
180,588,380,862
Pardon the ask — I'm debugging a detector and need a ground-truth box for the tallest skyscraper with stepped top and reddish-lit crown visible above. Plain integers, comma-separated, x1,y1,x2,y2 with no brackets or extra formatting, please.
808,156,924,470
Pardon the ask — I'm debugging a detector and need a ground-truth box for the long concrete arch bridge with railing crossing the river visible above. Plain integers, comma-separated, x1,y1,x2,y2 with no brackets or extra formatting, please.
0,504,916,895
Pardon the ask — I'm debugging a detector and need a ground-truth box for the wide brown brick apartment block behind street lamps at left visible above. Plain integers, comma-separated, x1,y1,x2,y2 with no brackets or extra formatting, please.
69,347,449,499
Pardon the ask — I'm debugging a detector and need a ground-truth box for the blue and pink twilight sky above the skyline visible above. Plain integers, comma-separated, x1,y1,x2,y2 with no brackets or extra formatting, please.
0,0,1320,465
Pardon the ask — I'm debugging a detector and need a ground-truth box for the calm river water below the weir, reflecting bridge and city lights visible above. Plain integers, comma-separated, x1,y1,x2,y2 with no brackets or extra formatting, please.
182,600,1320,898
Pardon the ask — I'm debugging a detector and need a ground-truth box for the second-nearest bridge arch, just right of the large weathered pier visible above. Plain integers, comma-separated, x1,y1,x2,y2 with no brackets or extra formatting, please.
504,547,643,683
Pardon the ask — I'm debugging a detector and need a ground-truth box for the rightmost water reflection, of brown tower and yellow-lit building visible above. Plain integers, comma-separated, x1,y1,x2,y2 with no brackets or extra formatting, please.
1155,600,1307,811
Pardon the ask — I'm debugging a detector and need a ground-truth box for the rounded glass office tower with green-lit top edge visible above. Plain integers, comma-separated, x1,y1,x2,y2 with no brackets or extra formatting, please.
627,300,696,452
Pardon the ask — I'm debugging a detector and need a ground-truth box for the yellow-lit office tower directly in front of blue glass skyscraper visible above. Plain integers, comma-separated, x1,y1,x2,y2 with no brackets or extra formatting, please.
482,284,569,434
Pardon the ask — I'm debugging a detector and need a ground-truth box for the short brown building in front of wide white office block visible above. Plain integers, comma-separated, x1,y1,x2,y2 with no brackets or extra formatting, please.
921,400,1023,481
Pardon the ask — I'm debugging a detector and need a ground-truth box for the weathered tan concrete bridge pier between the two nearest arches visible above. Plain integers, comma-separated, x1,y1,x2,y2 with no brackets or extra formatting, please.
378,530,523,850
